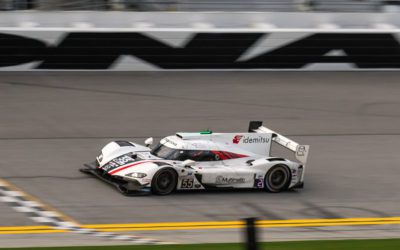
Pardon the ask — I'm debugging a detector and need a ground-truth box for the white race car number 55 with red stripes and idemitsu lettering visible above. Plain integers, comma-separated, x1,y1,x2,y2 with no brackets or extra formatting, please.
81,121,309,195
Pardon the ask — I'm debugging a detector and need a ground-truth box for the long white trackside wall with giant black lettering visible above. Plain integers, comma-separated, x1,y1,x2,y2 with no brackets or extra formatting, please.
0,12,400,71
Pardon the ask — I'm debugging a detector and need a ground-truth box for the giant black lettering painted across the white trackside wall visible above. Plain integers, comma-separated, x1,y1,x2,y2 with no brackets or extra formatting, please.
0,32,400,70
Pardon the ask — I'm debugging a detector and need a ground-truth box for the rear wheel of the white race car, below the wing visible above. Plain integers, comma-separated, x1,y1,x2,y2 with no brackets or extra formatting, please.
264,164,291,193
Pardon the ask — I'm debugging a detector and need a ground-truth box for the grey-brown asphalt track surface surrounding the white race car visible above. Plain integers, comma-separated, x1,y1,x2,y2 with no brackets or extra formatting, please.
0,72,400,245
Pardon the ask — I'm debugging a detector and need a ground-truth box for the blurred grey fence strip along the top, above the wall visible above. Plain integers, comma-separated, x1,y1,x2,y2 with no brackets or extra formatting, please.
0,0,400,12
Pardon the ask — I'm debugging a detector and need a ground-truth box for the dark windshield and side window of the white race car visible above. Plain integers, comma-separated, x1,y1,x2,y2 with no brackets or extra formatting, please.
151,143,220,161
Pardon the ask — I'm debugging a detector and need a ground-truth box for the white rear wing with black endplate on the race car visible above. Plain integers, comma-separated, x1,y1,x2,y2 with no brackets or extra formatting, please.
249,121,310,165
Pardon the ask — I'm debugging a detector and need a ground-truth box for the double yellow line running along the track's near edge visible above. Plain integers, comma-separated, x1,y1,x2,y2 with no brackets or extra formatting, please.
0,217,400,234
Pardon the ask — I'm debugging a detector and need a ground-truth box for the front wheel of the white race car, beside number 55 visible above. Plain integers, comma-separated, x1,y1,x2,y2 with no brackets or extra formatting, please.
151,168,178,195
